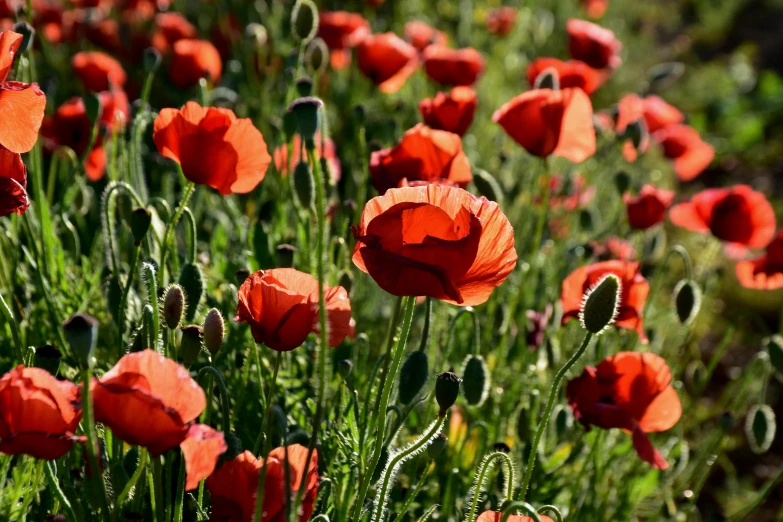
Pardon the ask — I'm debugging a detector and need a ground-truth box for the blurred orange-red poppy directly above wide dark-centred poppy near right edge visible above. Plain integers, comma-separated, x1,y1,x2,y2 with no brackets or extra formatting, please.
652,125,715,181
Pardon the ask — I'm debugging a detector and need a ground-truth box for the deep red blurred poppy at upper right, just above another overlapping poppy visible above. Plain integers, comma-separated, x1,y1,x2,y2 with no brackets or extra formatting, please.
566,18,623,69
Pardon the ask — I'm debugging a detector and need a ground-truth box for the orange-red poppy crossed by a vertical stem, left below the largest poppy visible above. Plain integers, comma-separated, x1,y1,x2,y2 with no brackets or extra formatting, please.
234,268,351,352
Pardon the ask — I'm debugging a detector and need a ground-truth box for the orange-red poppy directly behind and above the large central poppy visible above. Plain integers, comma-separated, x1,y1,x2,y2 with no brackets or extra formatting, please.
370,123,473,194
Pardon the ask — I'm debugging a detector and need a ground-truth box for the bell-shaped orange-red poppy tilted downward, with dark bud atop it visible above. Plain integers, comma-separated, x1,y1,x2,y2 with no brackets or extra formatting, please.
492,89,595,163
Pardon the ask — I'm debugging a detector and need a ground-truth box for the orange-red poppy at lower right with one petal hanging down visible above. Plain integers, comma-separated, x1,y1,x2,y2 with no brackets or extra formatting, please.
566,352,682,469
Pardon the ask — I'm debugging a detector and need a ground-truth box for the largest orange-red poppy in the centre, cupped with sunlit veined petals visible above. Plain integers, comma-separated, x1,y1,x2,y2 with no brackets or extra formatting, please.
353,185,517,306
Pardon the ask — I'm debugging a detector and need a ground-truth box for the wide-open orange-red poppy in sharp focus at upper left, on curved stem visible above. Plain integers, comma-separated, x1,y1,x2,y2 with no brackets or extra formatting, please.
152,101,272,195
